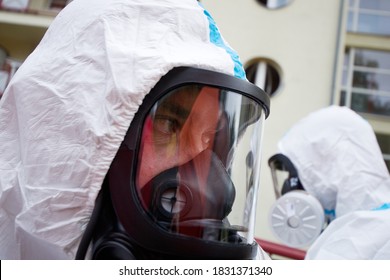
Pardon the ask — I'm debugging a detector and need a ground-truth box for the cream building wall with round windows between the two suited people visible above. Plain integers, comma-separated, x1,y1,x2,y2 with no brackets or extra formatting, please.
201,0,345,244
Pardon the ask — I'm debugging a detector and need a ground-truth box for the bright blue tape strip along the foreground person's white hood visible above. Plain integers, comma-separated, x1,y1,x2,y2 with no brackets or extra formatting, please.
199,3,246,80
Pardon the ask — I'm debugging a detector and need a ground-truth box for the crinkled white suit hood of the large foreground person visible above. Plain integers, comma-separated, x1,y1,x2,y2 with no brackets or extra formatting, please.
0,0,258,259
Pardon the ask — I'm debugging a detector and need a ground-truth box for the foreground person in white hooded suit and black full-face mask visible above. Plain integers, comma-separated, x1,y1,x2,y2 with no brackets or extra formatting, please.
0,0,269,259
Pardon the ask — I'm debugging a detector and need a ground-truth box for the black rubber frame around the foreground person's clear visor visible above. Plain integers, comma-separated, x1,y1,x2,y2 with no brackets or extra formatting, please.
76,67,270,259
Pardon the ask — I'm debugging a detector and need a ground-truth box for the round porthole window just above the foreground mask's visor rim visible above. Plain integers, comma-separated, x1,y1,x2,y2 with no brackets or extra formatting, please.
245,58,281,96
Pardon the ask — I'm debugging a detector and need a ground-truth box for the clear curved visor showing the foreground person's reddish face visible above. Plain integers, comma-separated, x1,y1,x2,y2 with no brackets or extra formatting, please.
136,85,265,244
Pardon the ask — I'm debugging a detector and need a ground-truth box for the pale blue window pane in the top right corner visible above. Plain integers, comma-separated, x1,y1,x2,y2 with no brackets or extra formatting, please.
347,0,390,35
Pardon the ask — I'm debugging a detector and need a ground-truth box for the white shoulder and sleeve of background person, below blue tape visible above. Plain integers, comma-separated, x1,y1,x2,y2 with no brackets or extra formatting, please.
305,210,390,260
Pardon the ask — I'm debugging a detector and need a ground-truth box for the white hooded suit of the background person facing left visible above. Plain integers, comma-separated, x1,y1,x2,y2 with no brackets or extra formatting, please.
278,106,390,259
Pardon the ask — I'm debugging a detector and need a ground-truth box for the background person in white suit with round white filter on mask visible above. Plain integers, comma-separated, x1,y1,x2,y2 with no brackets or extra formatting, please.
269,106,390,260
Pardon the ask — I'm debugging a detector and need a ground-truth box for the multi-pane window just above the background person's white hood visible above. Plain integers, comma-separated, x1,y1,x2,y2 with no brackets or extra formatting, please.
340,48,390,117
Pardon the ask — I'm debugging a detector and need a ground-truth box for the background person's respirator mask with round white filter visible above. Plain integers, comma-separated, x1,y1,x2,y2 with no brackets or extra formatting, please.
268,154,329,248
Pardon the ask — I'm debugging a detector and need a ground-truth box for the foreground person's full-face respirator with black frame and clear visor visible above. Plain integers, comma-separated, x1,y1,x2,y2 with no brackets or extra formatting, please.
76,67,269,259
